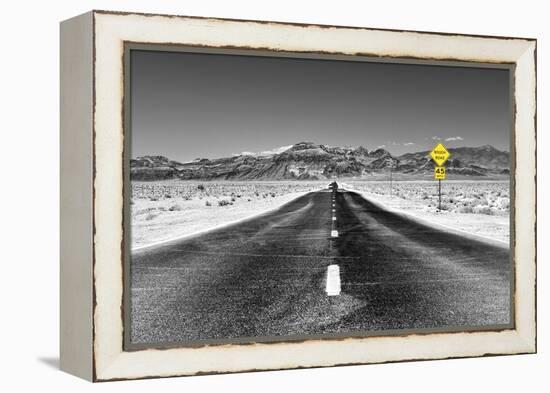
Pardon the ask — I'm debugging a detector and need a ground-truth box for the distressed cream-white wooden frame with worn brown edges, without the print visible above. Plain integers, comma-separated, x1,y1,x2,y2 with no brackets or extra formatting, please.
61,11,536,381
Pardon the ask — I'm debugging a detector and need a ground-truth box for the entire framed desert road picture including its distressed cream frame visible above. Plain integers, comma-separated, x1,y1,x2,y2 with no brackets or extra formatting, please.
60,11,536,381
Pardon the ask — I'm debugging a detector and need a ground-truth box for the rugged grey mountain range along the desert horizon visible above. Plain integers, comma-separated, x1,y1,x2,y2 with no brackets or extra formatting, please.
130,142,510,180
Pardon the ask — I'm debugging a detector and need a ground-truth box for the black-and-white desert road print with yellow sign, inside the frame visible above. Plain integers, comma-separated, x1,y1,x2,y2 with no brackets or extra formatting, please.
126,47,513,347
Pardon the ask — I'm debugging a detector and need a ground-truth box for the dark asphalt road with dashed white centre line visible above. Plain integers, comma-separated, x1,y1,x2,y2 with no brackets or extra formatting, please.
130,189,511,344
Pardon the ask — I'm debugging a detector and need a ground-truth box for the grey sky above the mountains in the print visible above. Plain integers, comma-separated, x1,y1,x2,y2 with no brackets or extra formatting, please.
131,51,510,162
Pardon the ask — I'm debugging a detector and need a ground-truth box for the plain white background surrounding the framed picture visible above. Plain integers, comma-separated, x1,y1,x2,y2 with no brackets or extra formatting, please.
0,0,550,393
